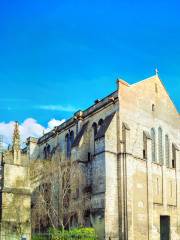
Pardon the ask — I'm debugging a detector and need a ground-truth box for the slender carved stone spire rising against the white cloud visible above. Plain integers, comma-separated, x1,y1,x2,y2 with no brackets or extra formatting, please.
13,121,21,164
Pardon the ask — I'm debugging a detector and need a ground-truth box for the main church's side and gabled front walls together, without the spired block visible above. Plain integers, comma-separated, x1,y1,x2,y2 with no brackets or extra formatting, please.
29,76,180,240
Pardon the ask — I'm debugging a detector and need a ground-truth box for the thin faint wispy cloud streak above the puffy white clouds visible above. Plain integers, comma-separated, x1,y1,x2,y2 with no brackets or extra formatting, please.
35,105,77,112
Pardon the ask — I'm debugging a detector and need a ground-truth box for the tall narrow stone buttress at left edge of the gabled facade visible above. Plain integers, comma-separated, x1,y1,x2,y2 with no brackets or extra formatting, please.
119,123,133,240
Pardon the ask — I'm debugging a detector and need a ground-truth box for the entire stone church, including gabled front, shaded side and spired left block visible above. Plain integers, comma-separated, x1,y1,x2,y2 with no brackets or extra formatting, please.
0,74,180,240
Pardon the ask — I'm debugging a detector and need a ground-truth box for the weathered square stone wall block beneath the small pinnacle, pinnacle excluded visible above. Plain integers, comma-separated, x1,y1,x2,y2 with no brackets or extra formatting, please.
0,156,31,240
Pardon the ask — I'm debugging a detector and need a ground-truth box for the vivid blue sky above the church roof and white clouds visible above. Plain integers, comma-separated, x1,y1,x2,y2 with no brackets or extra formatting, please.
0,0,180,126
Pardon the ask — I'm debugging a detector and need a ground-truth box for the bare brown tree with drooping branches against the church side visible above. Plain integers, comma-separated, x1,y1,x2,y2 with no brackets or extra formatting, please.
31,153,90,234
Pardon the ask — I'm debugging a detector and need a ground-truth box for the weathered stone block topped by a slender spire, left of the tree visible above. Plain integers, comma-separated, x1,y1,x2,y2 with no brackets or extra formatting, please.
0,123,31,240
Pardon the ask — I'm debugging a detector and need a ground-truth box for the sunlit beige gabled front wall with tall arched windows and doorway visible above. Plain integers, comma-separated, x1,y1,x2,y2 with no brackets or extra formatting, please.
118,76,180,240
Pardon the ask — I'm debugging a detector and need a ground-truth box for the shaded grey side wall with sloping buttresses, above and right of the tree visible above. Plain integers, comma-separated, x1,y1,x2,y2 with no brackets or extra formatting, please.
28,95,118,239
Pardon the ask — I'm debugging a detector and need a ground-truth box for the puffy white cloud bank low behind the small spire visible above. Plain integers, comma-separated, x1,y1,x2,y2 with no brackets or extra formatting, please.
0,118,65,147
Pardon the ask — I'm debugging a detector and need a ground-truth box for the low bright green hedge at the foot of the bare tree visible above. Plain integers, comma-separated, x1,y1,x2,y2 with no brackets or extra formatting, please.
50,228,97,240
